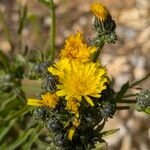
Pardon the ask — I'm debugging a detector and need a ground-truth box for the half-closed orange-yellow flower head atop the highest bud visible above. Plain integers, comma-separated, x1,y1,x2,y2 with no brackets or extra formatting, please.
90,3,110,22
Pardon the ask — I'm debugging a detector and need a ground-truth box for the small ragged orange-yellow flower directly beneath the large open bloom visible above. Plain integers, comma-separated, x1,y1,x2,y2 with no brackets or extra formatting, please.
66,98,80,117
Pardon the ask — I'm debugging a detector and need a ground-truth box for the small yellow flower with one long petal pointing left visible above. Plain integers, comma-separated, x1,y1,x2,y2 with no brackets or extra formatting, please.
27,92,59,108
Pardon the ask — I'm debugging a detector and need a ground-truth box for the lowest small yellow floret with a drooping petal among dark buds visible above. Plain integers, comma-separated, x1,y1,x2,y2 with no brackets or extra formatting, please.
68,118,80,141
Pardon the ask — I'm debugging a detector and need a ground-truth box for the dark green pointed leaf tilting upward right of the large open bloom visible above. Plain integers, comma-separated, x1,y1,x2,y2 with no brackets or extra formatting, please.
115,82,129,101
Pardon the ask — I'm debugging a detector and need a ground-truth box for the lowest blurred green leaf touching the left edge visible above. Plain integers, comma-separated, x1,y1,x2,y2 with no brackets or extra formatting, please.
0,119,16,142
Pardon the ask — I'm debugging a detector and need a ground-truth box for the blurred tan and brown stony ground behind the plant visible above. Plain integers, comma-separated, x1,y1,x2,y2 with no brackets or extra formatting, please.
0,0,150,150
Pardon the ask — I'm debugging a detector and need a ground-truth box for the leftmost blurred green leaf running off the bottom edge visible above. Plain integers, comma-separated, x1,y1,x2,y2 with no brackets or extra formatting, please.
7,128,34,150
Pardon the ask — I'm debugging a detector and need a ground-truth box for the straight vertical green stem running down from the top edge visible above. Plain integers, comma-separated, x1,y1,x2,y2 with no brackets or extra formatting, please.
48,0,56,62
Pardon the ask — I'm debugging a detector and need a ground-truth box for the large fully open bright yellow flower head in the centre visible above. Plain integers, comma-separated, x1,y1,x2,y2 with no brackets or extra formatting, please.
48,59,108,106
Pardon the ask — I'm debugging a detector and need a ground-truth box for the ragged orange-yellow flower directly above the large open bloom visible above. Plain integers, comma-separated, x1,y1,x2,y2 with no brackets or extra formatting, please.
60,32,96,62
